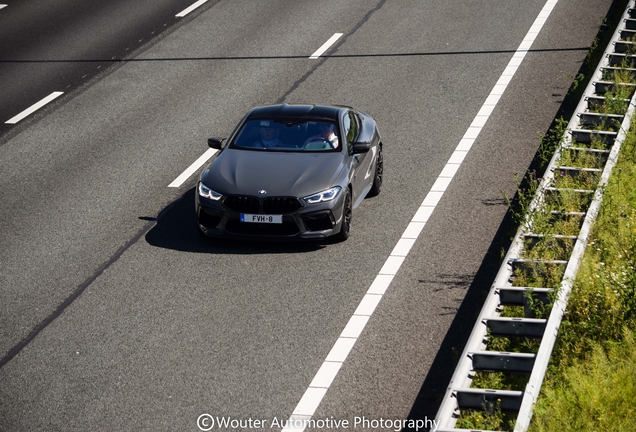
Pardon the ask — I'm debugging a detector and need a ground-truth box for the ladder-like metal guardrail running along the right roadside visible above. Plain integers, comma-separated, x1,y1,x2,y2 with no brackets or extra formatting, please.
434,0,636,432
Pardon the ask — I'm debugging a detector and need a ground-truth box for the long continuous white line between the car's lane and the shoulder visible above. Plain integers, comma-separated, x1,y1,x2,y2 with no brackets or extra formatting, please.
283,0,558,432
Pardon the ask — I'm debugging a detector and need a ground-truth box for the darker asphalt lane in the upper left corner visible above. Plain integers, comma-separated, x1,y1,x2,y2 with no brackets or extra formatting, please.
0,0,209,139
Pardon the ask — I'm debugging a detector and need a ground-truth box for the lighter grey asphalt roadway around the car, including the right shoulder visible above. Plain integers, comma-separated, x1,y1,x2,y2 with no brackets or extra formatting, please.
0,1,608,430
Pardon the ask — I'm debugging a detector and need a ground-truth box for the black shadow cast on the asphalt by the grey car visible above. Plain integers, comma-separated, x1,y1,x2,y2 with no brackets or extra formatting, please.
146,188,333,255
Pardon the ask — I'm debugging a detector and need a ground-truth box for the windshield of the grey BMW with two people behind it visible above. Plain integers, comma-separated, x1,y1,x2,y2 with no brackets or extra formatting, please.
231,119,340,152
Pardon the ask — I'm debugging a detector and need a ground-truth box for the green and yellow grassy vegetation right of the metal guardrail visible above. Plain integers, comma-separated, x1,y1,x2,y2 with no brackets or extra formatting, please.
531,114,636,432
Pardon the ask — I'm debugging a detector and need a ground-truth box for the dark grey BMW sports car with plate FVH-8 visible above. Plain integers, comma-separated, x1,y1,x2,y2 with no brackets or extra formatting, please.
196,104,383,241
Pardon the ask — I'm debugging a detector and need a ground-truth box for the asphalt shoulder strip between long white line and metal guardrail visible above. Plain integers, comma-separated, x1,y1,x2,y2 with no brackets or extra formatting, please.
315,1,622,430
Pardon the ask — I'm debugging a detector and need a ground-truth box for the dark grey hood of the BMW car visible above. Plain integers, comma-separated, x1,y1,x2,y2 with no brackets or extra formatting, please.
201,149,345,197
